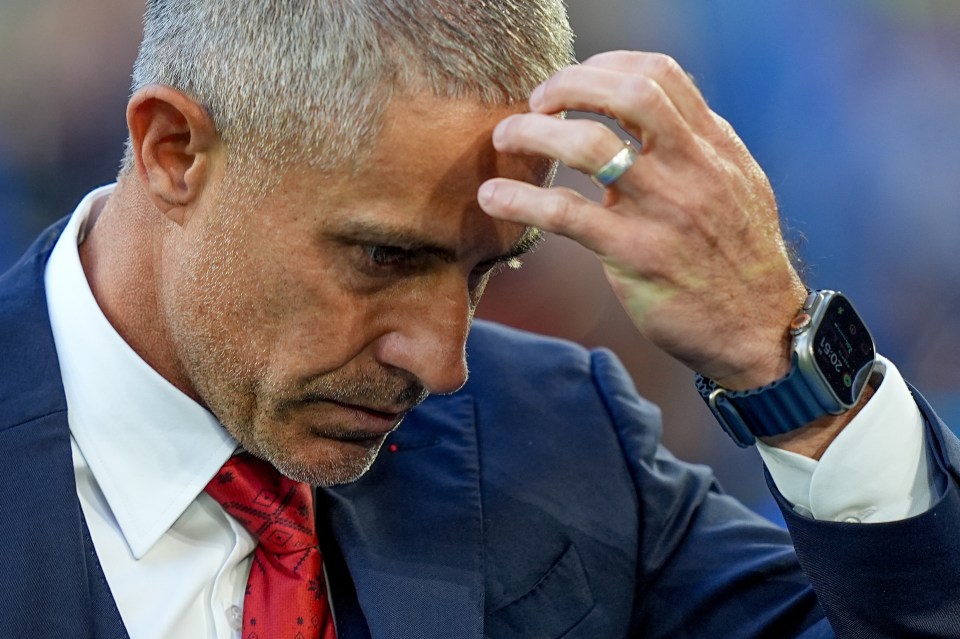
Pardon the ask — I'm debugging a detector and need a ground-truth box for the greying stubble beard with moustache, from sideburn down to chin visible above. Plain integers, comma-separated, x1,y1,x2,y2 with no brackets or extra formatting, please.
164,184,427,486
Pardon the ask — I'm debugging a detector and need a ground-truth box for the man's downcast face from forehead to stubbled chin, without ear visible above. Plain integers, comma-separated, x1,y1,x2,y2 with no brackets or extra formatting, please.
161,98,546,485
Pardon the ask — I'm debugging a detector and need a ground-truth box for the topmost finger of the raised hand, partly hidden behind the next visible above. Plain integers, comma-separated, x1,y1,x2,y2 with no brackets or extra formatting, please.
582,51,711,129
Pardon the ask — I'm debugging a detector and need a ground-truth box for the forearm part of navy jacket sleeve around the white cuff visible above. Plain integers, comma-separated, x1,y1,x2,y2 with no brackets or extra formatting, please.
767,391,960,637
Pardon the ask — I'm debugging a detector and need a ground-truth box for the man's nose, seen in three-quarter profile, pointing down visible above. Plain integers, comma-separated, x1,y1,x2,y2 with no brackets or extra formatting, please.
377,282,473,394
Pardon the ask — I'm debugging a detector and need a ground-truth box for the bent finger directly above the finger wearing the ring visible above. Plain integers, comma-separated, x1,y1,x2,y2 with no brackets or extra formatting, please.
530,66,692,151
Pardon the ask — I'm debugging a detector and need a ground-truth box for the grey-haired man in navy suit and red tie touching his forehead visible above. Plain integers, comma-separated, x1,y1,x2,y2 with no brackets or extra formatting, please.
0,0,960,639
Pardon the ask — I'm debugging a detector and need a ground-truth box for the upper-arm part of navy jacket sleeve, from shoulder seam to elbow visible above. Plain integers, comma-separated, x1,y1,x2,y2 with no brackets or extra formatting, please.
592,350,834,639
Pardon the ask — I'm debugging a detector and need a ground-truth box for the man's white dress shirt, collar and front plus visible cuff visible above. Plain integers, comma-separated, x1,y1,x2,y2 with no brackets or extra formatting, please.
46,186,932,639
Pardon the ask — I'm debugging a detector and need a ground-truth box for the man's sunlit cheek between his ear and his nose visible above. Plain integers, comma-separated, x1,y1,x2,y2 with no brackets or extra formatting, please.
181,218,394,387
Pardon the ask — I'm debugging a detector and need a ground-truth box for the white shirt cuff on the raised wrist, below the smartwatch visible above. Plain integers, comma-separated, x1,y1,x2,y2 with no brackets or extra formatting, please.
757,357,935,523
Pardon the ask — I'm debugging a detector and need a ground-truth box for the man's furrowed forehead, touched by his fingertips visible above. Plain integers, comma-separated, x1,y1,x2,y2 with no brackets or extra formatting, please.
290,97,550,254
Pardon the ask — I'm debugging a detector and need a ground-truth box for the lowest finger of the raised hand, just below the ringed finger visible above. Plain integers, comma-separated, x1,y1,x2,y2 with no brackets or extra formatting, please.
477,178,619,252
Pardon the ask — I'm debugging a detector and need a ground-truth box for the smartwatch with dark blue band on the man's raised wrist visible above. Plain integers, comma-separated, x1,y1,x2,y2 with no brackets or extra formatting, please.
696,291,876,448
